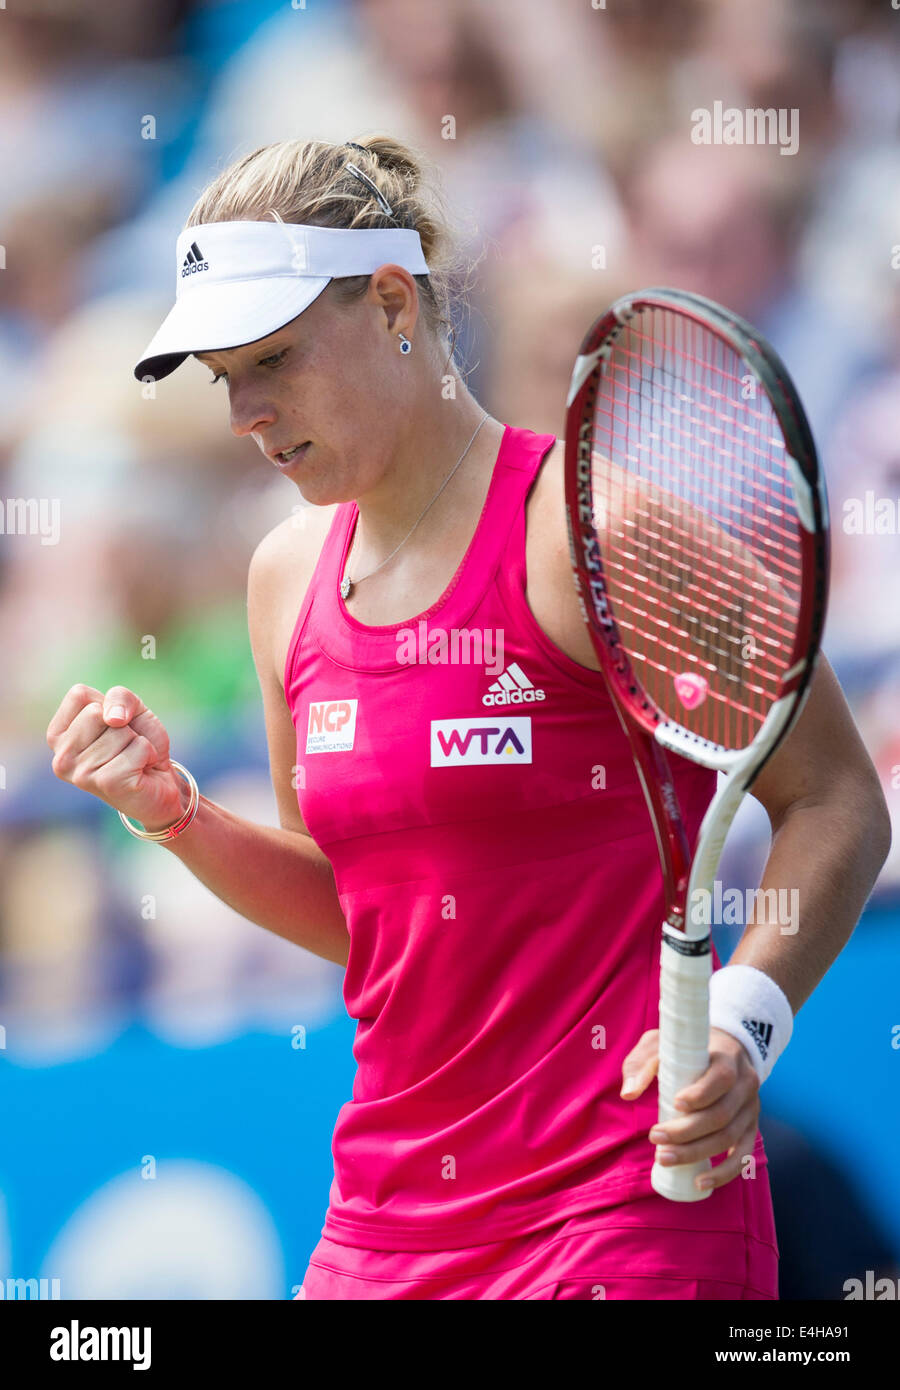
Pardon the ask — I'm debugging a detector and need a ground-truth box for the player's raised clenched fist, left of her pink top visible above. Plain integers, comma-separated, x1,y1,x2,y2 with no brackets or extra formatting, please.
47,685,185,830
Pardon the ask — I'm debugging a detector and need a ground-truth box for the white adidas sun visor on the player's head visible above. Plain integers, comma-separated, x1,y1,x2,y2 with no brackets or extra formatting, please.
135,222,428,381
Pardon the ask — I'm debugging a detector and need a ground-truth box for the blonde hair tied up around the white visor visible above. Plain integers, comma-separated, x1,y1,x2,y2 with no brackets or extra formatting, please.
185,135,467,357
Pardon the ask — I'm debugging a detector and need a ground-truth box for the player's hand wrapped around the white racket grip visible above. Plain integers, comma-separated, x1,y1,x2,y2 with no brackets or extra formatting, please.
622,1029,760,1187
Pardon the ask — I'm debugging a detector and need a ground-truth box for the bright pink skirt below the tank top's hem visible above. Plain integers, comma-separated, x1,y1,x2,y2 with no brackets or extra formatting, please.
296,1166,778,1300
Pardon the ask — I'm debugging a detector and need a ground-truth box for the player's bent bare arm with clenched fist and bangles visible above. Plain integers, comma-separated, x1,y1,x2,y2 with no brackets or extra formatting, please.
47,511,349,966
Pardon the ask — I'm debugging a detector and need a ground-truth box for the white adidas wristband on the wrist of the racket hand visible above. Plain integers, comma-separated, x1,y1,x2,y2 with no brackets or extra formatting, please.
709,965,794,1086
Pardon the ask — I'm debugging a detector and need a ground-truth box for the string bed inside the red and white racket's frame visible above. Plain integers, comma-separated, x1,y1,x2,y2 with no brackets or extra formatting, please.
593,309,801,748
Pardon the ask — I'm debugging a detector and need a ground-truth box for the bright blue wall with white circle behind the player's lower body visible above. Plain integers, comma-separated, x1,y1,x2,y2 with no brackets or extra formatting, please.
0,908,900,1300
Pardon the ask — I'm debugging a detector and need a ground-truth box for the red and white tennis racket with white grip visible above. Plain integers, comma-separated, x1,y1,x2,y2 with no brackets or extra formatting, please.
565,289,829,1201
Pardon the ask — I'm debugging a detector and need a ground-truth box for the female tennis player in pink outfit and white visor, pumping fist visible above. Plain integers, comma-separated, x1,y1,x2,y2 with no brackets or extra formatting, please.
47,136,889,1300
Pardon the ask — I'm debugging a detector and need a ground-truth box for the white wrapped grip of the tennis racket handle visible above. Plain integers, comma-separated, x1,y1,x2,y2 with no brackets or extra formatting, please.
650,931,712,1202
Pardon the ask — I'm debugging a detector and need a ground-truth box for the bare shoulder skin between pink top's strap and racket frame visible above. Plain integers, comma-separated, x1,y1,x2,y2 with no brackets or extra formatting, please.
526,439,600,671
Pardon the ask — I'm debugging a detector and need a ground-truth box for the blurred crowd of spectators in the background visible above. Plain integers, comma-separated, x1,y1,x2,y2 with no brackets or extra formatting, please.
0,0,900,1047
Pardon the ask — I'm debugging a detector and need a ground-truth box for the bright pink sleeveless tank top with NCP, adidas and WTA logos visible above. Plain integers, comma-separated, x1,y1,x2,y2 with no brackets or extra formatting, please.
285,425,723,1250
